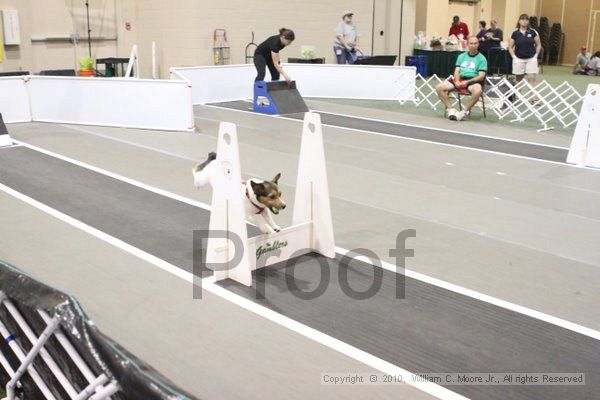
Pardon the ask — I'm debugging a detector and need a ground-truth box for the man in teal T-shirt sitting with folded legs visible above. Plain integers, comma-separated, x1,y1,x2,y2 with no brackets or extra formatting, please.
436,36,487,121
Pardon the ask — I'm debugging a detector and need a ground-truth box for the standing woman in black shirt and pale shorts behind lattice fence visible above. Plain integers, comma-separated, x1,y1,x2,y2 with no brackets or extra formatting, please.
508,14,542,86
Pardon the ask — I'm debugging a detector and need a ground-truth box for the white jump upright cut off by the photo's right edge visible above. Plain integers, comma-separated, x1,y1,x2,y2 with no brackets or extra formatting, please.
567,84,600,168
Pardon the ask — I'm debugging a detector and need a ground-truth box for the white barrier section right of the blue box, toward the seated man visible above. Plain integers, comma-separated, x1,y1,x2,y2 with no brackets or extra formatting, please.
283,64,416,100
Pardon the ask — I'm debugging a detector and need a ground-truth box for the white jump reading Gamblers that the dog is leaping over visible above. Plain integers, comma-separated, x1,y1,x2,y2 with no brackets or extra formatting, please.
206,113,335,286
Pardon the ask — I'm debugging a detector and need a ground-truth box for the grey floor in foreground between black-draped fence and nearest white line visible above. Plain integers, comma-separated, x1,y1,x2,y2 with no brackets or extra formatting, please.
0,193,431,399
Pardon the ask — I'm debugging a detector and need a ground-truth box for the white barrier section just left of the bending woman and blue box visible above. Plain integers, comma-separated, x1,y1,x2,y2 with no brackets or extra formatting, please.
171,64,254,104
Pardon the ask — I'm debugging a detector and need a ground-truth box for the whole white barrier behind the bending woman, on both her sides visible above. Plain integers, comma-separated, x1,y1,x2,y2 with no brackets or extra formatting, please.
171,64,416,104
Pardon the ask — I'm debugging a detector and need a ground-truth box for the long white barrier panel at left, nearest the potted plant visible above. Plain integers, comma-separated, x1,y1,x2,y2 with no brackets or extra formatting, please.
28,76,194,131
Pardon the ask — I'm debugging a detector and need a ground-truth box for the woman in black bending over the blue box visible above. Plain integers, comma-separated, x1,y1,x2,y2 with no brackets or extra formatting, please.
254,28,296,82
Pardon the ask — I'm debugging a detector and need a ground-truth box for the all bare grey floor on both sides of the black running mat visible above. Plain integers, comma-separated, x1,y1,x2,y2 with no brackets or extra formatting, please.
0,102,600,399
